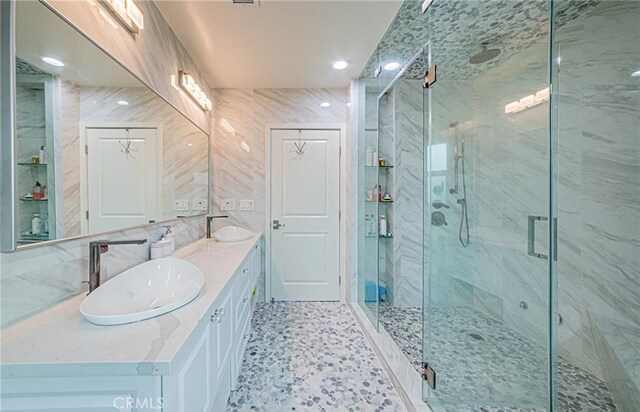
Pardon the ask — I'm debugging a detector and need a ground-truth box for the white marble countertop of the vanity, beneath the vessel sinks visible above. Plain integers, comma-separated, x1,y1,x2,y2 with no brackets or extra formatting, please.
0,233,261,378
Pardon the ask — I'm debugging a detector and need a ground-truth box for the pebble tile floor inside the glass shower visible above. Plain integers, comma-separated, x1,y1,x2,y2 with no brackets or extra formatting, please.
379,304,616,412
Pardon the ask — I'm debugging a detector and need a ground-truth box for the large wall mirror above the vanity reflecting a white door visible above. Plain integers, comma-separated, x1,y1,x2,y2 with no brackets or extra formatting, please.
14,1,209,246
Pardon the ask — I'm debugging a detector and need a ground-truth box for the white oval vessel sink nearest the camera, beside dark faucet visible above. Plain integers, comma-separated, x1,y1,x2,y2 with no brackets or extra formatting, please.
80,258,204,325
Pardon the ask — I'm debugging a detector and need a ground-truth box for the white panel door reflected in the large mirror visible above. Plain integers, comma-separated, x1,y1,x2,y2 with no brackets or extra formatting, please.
87,128,162,233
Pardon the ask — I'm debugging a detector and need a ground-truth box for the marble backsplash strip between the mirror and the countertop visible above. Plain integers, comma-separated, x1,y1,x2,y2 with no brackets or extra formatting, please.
0,217,205,327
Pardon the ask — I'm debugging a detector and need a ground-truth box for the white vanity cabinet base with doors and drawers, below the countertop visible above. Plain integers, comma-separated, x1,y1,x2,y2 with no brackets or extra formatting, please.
0,241,262,412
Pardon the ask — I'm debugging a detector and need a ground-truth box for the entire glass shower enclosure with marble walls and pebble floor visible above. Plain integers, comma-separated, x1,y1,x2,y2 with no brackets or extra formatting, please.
359,0,640,412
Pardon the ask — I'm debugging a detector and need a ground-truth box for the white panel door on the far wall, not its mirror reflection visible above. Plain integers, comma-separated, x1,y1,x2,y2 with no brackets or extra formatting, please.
271,130,340,301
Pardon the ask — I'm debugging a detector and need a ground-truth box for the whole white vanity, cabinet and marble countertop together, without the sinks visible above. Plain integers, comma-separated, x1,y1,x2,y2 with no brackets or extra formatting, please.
1,234,263,412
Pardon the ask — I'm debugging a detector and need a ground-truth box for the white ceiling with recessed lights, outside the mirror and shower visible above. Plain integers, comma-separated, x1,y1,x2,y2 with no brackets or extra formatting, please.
156,0,402,88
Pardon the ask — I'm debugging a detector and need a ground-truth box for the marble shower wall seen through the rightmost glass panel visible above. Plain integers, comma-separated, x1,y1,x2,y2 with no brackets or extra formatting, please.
555,1,640,380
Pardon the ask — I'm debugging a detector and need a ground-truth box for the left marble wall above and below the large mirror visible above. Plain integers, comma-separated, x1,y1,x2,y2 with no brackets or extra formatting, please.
0,0,209,325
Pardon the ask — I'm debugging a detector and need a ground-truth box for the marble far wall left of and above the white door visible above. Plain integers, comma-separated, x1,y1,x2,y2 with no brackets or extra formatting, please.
212,89,348,232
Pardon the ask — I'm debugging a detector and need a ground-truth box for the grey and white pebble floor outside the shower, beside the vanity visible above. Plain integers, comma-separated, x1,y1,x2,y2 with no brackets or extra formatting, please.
227,302,406,412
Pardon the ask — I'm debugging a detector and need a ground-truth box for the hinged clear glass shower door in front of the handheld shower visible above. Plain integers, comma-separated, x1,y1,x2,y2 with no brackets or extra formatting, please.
424,0,553,412
